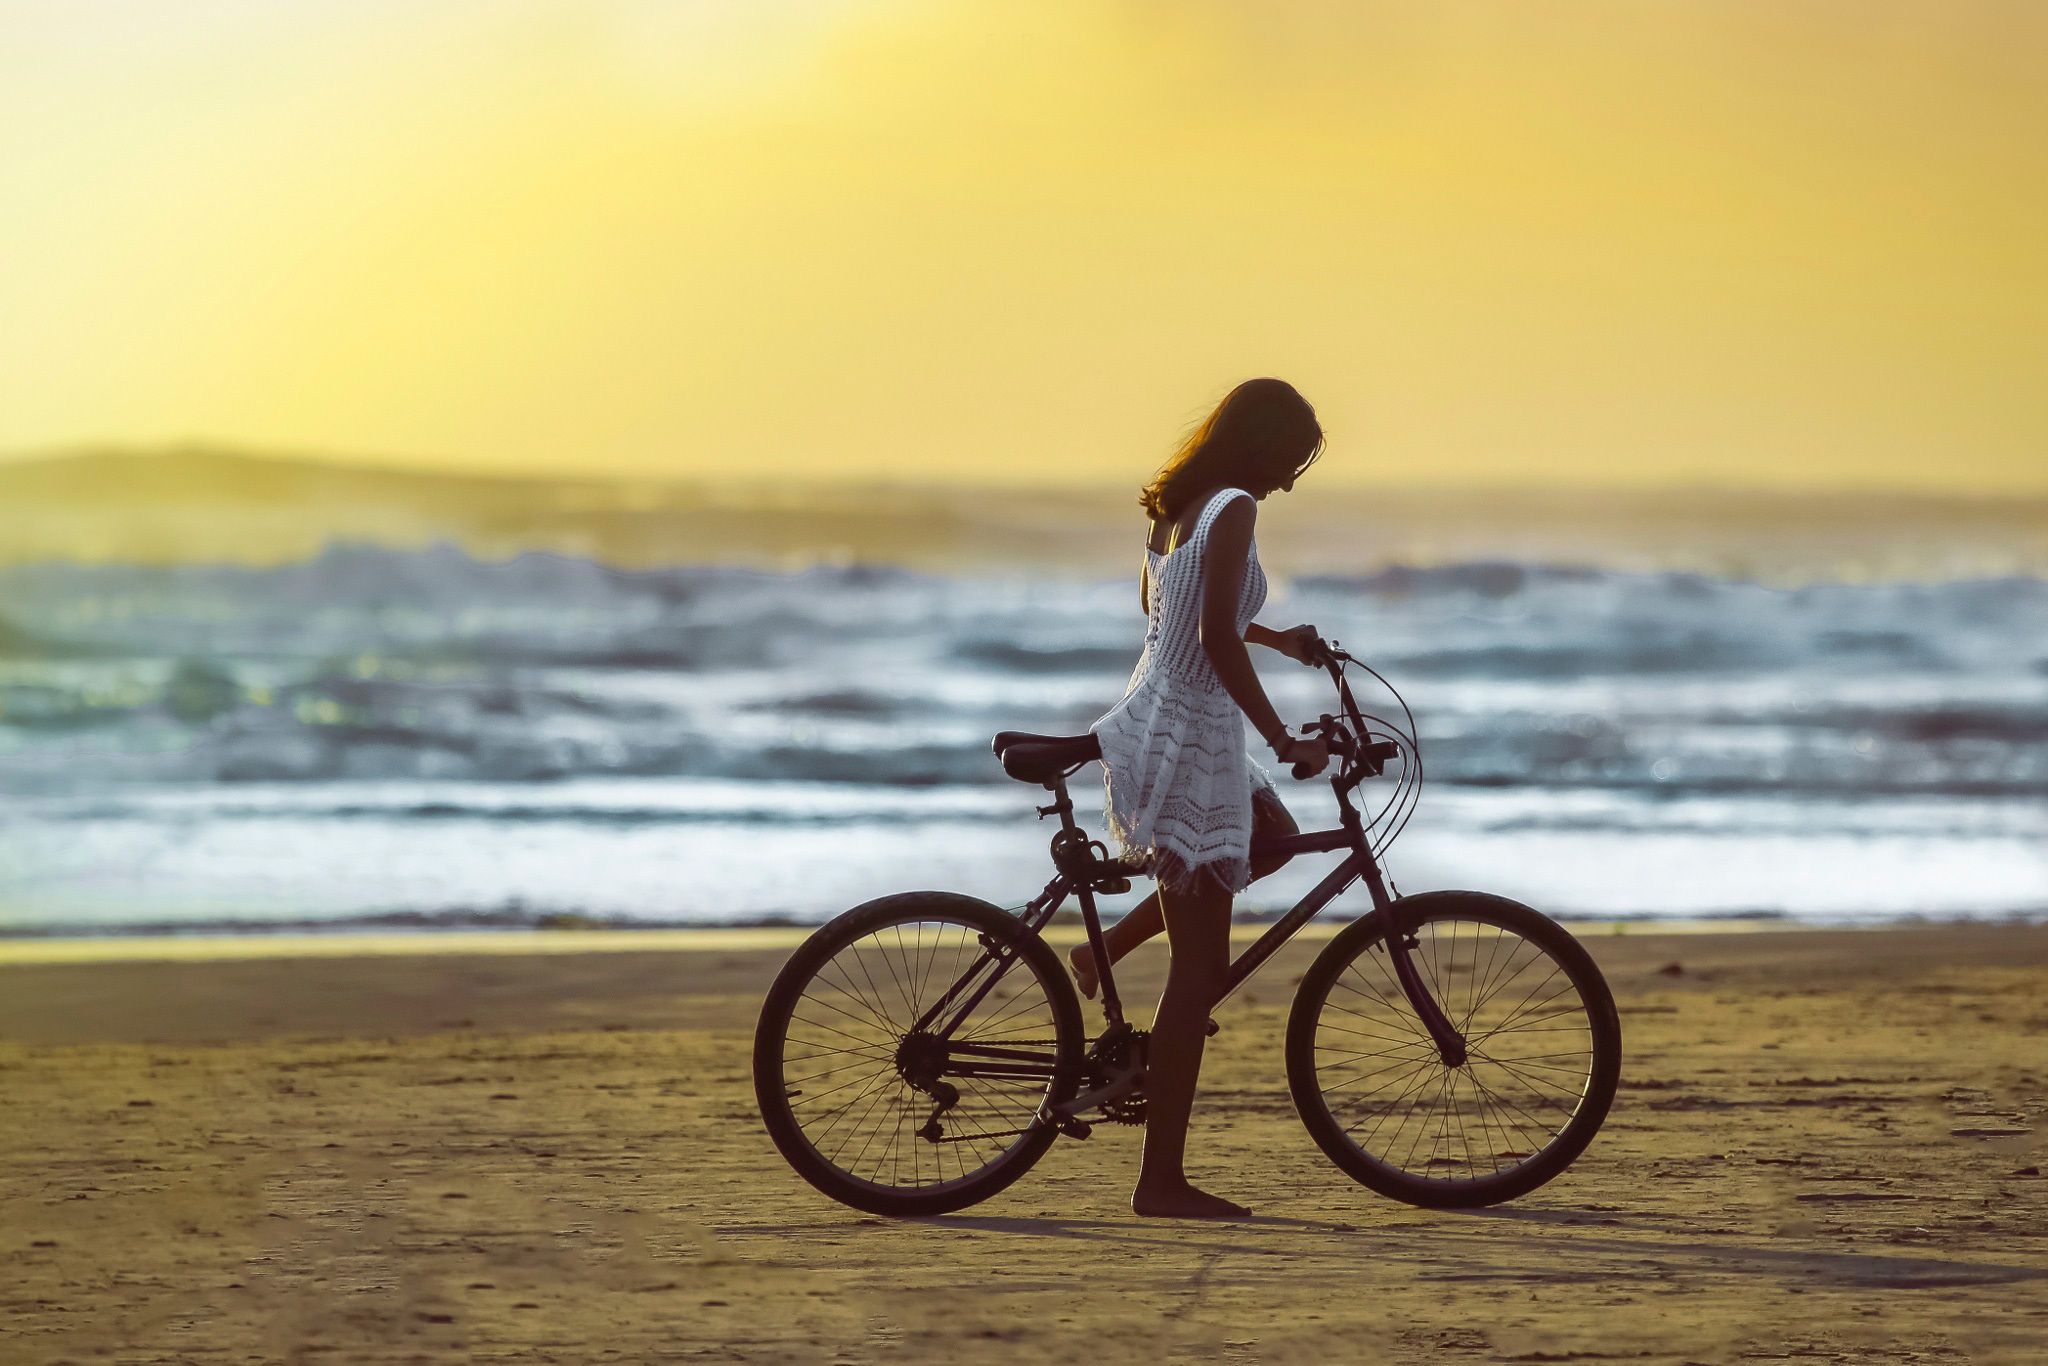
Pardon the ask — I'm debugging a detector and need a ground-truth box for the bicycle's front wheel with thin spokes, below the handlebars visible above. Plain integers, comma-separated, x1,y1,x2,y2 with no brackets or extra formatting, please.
1286,891,1622,1208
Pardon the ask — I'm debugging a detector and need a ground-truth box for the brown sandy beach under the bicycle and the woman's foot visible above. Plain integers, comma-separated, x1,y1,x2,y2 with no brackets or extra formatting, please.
0,926,2048,1362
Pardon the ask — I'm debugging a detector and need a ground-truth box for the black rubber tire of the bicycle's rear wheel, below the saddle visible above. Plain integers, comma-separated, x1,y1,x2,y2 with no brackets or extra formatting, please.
754,891,1083,1216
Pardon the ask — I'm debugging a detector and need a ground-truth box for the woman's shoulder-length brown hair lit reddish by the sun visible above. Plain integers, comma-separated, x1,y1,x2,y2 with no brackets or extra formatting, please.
1139,379,1323,520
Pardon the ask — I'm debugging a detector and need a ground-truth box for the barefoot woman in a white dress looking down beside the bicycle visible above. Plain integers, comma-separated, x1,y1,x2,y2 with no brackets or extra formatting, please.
1073,379,1329,1219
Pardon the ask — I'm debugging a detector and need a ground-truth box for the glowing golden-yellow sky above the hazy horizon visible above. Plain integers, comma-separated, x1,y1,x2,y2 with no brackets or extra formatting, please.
0,0,2048,489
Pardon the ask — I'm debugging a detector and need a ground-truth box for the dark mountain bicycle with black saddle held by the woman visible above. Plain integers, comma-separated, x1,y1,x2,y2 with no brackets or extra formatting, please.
754,641,1622,1214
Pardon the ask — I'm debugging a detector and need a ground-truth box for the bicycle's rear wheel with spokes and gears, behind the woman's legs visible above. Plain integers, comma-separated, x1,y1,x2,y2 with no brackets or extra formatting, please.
754,891,1083,1214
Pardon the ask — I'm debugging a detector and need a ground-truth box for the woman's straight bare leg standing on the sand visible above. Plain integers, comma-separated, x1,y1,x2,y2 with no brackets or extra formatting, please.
1130,864,1249,1219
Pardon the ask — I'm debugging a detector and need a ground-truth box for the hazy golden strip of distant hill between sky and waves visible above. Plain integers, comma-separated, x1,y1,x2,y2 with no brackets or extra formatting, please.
0,449,2048,580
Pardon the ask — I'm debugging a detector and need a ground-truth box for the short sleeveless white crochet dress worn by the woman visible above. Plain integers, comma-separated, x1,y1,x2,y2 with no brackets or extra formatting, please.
1087,487,1272,893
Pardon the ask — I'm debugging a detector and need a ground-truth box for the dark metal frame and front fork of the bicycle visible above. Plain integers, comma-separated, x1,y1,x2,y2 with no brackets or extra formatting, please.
913,666,1466,1077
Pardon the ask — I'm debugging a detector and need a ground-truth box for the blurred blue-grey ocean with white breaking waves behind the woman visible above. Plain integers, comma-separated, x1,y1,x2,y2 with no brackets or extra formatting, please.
0,543,2048,936
